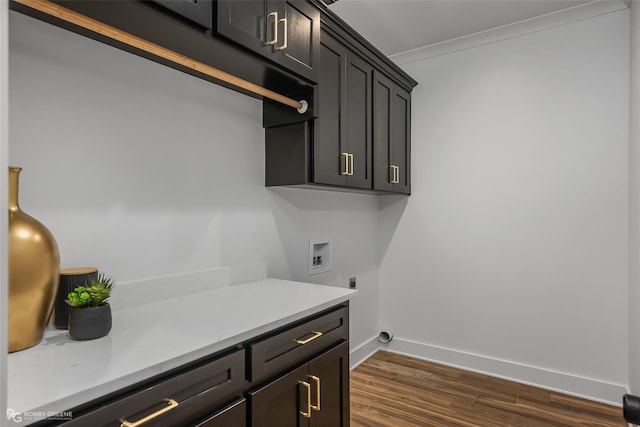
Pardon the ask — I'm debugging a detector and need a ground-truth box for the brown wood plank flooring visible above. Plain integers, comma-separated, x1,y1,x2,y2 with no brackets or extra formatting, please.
350,351,627,427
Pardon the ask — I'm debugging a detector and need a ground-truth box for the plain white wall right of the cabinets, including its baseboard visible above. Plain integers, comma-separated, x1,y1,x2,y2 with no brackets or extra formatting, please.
380,10,629,404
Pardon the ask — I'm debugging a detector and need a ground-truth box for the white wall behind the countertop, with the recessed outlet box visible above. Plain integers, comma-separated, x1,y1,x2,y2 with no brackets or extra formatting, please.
9,12,378,354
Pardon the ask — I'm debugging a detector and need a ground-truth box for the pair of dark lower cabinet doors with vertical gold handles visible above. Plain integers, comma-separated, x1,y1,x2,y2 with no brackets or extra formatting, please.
249,342,349,427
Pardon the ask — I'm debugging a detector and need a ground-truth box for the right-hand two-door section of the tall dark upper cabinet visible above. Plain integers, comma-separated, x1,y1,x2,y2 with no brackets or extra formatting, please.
373,71,411,194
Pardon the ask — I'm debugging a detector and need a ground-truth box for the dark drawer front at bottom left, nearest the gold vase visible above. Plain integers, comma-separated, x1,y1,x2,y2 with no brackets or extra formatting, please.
63,350,246,427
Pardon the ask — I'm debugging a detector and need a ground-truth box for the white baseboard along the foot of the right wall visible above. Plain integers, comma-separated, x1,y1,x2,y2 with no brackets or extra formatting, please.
382,337,627,407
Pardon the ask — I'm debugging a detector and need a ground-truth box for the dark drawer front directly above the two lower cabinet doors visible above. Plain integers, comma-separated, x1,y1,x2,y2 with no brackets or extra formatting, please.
248,307,349,381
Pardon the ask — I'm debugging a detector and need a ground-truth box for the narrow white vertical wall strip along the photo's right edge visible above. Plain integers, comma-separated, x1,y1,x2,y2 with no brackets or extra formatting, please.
629,0,640,395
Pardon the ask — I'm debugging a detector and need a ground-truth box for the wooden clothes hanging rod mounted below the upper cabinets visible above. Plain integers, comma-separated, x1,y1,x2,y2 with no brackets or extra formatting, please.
15,0,309,114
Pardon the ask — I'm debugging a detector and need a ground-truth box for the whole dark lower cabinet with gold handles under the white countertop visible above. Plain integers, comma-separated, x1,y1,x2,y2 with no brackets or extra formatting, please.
34,303,349,427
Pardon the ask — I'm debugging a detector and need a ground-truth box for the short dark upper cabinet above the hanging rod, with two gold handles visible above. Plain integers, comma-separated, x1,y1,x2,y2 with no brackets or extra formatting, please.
216,0,320,82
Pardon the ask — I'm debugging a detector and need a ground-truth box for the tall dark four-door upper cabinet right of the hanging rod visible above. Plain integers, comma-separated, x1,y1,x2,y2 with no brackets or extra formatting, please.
265,27,411,194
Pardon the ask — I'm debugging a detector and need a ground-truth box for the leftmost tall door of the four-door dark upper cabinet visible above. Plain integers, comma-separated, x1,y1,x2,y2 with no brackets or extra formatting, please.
313,34,346,186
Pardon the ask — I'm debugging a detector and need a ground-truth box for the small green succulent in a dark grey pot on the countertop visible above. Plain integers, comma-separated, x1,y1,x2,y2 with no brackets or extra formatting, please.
65,273,115,341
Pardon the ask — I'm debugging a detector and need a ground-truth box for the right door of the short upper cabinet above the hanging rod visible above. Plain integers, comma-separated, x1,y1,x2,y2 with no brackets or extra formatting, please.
277,0,320,81
